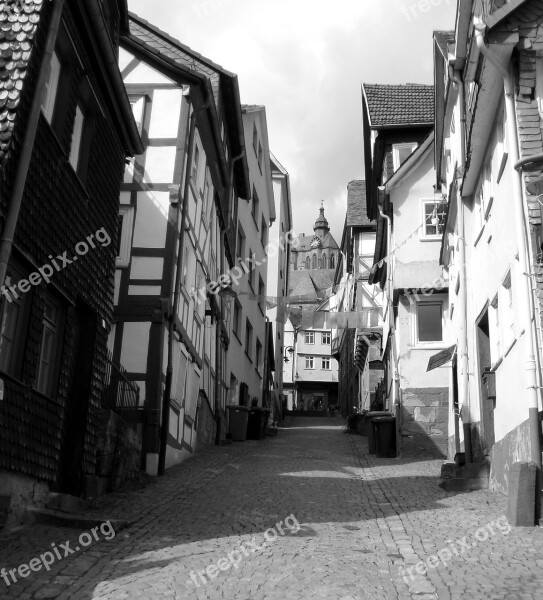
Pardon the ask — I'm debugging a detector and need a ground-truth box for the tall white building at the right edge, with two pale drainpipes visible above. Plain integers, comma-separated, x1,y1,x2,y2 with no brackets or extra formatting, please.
434,1,543,496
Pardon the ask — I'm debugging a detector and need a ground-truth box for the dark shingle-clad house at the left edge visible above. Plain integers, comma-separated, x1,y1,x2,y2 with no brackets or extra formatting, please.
0,0,141,516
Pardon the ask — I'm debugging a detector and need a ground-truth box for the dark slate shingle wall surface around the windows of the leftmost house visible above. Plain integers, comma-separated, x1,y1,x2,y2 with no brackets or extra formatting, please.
0,2,124,482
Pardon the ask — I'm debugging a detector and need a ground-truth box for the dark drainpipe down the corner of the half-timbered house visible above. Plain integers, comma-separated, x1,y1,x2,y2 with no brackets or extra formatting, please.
158,92,211,475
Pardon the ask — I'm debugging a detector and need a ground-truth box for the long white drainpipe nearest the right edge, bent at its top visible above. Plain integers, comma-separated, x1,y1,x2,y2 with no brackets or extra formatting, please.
474,19,541,522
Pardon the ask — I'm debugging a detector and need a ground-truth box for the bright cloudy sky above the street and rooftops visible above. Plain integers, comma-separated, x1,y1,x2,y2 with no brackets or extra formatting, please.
128,0,456,243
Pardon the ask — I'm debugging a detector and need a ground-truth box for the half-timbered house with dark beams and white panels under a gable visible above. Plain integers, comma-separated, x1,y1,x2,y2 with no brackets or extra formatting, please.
115,15,250,474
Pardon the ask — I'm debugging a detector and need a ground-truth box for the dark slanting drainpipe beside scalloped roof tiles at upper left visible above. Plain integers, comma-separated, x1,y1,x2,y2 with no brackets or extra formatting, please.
0,0,65,285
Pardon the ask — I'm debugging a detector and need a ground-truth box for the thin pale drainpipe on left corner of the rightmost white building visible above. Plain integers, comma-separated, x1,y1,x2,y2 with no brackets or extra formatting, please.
449,66,473,463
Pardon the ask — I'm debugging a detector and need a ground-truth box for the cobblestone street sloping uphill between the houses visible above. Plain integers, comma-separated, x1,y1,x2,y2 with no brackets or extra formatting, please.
0,418,543,600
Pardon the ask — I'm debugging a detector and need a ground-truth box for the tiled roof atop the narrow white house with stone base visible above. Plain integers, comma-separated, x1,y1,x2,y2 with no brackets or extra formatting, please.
362,83,434,129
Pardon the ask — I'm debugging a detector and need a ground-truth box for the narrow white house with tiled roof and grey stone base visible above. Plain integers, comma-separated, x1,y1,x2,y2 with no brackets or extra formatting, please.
363,84,450,456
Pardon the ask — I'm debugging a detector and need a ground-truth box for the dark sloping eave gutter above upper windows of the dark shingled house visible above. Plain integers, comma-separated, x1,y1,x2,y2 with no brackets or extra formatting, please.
86,0,144,154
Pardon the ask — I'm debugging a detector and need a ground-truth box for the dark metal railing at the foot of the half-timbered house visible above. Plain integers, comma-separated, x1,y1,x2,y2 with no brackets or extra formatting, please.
102,352,143,429
